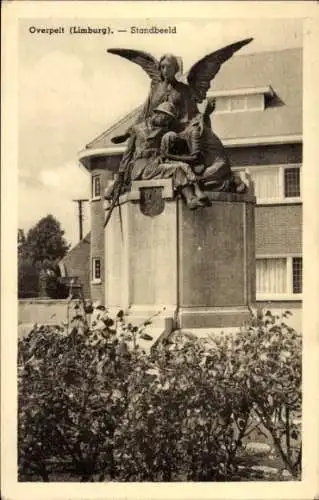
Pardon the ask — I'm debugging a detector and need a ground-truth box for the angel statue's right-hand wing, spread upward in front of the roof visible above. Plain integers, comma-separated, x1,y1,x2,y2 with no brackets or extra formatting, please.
187,38,253,103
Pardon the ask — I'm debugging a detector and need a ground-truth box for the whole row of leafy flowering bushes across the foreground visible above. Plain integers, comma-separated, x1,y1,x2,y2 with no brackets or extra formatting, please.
19,305,301,481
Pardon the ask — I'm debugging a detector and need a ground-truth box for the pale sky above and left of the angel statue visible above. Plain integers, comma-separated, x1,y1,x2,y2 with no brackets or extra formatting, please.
18,17,302,244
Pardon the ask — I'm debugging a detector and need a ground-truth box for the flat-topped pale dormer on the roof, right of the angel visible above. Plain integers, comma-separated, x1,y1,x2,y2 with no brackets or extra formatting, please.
207,86,274,114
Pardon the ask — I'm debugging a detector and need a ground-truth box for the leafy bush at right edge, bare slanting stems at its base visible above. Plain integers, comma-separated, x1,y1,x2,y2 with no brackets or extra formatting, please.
242,311,302,478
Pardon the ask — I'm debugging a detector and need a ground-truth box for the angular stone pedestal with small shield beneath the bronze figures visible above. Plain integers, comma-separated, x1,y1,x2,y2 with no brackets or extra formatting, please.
105,180,255,330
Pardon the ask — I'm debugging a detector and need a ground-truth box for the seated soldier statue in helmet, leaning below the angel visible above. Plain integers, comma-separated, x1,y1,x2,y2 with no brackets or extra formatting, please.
105,102,209,209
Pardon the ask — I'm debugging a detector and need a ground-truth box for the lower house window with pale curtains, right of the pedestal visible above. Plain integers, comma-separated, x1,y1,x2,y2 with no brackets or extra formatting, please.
256,257,302,300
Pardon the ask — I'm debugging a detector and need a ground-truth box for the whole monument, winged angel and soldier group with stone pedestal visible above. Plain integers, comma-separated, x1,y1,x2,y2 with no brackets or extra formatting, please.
105,38,255,331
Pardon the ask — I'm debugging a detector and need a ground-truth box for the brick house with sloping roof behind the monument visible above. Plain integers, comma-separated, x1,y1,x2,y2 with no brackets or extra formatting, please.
80,49,302,330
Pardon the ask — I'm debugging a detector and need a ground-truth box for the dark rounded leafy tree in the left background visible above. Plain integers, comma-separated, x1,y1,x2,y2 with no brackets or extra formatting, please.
22,214,70,264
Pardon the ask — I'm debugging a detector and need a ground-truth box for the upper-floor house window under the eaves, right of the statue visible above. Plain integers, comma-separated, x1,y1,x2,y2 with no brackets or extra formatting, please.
233,165,301,204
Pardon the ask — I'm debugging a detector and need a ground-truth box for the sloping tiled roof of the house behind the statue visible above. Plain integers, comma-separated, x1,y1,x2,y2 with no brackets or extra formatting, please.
82,48,302,149
